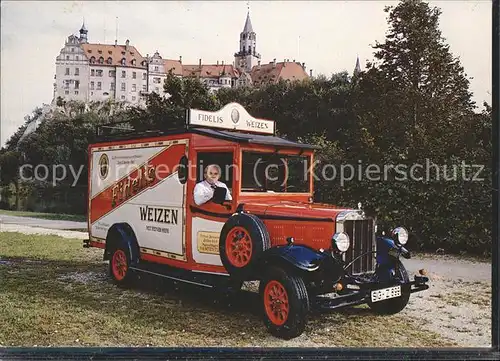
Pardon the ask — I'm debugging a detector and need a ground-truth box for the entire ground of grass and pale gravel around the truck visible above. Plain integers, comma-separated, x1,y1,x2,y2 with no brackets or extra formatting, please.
0,225,491,347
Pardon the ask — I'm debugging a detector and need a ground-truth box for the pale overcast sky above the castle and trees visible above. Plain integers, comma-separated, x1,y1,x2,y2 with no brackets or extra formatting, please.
0,0,492,146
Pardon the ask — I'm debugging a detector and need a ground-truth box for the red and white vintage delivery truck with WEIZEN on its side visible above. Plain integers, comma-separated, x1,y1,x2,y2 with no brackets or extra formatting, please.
84,103,429,339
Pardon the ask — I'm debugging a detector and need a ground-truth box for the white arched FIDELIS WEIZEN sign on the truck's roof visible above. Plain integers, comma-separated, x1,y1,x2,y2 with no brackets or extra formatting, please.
186,103,275,134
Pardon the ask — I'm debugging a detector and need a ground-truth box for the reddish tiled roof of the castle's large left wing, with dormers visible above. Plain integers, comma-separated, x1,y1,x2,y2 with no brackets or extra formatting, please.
81,44,146,68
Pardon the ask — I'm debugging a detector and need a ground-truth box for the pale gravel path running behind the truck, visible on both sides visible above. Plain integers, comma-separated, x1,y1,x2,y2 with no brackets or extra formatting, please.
0,222,491,347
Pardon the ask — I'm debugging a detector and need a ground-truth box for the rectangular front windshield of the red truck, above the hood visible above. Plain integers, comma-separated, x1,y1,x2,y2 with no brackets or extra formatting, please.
241,151,309,193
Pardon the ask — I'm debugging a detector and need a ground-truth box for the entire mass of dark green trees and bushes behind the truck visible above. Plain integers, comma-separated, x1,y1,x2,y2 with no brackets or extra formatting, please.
0,0,492,253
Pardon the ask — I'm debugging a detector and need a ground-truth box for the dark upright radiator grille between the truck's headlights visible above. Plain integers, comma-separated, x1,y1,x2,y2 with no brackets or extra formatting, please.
344,219,375,274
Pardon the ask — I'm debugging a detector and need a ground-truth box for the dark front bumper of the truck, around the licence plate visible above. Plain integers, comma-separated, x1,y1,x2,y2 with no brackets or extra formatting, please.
311,276,429,311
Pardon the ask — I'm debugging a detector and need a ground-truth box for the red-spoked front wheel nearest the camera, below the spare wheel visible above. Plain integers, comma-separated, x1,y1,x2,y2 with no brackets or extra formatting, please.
259,268,309,340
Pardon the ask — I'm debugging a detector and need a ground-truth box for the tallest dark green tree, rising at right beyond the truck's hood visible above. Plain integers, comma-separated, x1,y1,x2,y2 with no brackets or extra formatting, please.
349,0,489,250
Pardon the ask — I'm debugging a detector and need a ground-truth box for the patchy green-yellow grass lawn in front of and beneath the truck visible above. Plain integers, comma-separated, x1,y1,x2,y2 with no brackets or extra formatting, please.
0,233,454,347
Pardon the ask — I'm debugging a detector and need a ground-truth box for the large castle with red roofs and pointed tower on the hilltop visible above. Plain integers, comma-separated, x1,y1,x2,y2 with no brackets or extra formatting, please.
54,13,312,105
